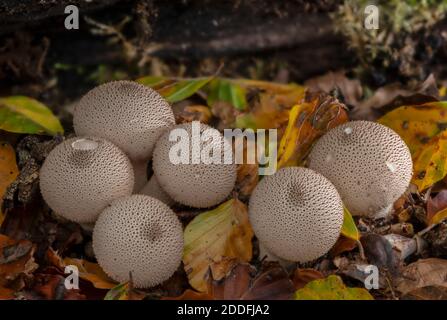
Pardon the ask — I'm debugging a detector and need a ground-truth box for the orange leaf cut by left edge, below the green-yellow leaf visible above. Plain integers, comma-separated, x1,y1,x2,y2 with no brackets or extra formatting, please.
0,143,19,225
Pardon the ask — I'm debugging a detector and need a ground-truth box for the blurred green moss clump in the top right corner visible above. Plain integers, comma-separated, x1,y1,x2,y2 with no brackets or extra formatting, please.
332,0,447,85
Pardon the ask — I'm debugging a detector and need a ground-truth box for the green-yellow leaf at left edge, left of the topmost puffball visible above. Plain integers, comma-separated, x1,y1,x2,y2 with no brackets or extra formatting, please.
0,96,64,135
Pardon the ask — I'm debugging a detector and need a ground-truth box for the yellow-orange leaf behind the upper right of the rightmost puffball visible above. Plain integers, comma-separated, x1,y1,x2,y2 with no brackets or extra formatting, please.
378,102,447,155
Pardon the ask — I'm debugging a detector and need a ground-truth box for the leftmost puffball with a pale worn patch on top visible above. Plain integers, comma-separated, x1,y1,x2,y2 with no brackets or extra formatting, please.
40,137,134,223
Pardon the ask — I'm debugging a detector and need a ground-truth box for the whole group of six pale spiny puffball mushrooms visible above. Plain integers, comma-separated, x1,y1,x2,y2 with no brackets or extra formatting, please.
40,81,412,288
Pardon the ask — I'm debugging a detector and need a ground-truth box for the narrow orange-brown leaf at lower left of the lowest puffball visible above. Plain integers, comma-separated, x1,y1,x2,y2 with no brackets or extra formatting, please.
64,258,117,289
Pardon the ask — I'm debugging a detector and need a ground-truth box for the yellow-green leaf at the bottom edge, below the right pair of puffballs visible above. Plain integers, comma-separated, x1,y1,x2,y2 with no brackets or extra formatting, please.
294,275,374,300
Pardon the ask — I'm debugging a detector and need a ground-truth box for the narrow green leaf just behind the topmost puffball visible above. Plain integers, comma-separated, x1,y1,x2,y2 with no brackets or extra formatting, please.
137,77,212,103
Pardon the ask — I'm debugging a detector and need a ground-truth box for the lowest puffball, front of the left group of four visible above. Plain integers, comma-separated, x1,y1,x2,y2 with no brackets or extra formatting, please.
93,195,183,288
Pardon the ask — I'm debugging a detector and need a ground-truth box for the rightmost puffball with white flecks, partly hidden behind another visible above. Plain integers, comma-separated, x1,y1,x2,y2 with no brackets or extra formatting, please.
308,121,413,218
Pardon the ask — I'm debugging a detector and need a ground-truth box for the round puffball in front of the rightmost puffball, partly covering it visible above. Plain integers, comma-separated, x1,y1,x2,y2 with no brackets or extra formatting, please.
249,167,343,262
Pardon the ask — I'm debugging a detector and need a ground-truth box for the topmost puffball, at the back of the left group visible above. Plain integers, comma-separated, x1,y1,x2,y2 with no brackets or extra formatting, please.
73,81,175,160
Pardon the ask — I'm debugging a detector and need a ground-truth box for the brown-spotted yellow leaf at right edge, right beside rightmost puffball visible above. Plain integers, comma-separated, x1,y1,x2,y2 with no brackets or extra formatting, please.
412,131,447,191
